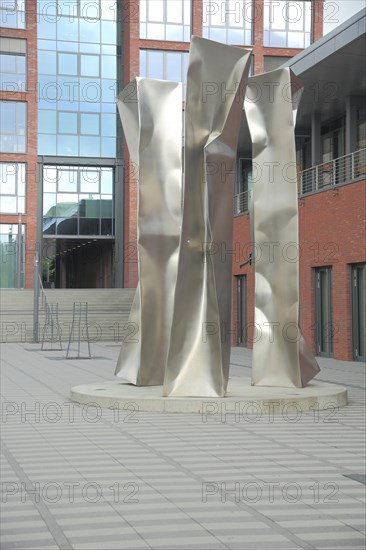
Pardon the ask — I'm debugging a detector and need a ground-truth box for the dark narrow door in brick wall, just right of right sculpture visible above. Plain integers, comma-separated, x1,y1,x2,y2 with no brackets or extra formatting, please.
315,267,333,357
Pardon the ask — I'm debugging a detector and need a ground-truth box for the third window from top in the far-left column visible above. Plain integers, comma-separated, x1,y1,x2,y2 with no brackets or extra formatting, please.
0,101,27,153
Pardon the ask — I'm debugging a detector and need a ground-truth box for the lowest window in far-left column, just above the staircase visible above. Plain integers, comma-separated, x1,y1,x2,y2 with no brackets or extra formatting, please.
0,223,25,288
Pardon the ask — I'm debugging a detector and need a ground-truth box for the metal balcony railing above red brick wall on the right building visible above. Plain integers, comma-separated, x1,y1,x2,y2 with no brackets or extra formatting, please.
234,149,366,215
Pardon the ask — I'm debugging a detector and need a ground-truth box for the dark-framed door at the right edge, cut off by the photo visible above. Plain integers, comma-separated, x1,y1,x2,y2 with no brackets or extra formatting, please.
352,264,366,361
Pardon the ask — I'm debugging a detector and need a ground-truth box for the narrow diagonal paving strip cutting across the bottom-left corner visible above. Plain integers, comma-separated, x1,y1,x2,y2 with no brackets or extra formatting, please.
1,442,72,550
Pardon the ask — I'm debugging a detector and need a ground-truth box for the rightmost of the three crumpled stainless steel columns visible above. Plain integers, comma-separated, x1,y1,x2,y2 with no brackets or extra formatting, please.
244,69,319,388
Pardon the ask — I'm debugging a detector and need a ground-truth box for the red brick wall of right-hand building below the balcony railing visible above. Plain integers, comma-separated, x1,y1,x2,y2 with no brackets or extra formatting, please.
232,180,366,360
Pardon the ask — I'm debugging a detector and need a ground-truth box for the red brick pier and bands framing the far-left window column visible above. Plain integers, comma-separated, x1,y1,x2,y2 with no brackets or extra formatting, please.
0,0,38,288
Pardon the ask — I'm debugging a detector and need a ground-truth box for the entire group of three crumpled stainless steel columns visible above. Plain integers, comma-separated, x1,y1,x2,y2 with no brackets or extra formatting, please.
116,44,319,397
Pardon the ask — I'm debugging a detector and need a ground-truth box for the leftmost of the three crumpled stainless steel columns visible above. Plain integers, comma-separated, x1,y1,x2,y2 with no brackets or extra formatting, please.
115,78,182,385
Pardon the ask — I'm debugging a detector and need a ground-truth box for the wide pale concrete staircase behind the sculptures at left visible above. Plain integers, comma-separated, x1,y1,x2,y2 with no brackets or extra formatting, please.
0,288,137,342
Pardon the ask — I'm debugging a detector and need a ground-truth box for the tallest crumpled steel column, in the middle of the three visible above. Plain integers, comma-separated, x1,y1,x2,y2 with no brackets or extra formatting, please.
163,37,251,396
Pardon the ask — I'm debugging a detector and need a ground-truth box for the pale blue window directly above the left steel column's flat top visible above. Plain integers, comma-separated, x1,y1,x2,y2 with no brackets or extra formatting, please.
140,50,188,97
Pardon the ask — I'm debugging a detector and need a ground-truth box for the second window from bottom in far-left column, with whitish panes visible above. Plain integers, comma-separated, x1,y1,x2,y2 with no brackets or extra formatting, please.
0,162,25,214
